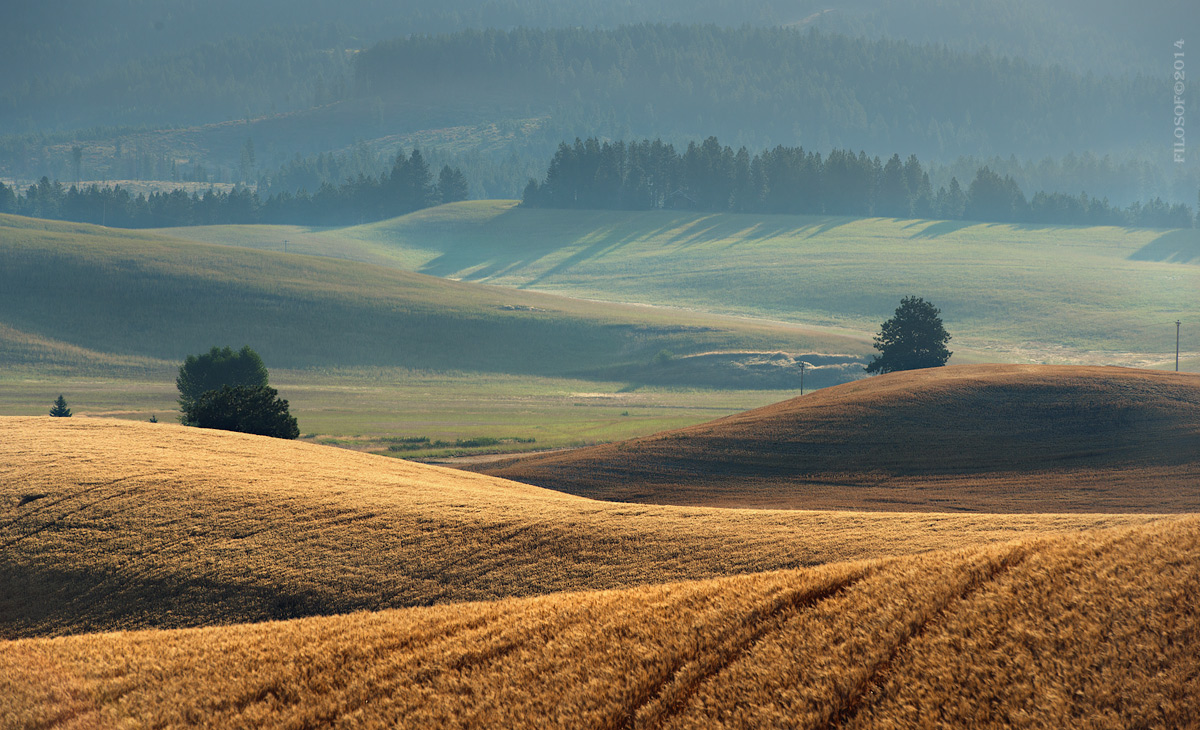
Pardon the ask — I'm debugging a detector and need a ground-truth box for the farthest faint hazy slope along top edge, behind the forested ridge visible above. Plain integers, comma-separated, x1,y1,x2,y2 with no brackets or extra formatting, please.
0,0,1176,131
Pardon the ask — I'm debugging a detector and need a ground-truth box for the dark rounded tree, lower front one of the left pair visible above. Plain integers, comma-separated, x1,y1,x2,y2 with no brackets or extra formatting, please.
184,385,300,438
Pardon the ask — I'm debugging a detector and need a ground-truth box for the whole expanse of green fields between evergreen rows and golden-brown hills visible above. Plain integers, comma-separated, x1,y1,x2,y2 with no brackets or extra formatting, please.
0,201,1200,457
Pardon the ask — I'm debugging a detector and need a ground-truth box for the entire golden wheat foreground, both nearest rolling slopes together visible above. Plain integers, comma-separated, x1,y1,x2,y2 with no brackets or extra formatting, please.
0,396,1200,729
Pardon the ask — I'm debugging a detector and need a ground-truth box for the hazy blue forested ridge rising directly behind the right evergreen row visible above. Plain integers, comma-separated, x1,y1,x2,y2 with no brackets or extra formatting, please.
354,25,1166,165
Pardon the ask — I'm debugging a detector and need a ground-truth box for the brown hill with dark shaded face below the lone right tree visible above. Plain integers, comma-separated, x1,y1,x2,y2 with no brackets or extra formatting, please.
470,365,1200,513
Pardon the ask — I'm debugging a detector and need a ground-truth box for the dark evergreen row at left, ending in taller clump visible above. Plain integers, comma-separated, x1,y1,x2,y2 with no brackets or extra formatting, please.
0,150,468,228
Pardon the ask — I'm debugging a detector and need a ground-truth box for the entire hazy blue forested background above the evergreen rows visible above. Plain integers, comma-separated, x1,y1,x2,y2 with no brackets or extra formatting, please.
0,0,1200,208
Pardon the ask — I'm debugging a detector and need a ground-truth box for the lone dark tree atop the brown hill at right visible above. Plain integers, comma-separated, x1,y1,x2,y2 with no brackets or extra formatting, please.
866,297,952,372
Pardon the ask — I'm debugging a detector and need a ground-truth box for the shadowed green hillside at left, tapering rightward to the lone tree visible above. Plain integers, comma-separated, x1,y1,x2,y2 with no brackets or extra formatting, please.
0,216,866,377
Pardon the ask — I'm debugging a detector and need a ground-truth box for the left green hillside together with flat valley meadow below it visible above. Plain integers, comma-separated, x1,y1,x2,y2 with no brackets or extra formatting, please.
0,211,869,457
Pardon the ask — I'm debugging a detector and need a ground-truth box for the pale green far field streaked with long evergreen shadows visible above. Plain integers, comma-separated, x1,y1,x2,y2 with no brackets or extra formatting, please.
159,201,1200,370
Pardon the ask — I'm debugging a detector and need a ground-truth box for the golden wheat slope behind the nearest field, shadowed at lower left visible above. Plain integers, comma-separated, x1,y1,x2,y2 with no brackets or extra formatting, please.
0,417,1152,638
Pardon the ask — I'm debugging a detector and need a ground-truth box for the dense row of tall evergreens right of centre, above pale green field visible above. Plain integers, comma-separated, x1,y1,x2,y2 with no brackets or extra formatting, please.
522,137,1195,228
